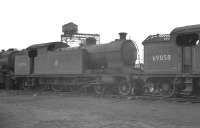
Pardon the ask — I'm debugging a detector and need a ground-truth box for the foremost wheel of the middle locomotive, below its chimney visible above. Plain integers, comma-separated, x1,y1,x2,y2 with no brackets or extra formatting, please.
118,80,132,96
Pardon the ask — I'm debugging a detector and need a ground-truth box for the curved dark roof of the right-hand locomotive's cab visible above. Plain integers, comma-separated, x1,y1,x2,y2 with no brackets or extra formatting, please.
170,24,200,35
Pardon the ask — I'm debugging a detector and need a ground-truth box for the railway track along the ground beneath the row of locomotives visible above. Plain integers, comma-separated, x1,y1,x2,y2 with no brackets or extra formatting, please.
0,90,200,103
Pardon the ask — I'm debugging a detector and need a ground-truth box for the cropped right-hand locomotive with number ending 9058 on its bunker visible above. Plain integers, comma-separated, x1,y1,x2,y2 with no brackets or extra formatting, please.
143,25,200,96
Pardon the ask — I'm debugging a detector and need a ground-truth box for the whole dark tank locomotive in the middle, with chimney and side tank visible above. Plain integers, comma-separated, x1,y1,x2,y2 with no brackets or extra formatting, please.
15,30,138,95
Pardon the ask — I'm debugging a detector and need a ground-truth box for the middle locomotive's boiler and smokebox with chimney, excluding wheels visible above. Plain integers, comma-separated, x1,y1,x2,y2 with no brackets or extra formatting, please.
86,33,137,73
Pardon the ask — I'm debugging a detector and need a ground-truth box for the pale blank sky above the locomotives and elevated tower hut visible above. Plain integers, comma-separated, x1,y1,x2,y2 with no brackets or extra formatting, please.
0,0,200,58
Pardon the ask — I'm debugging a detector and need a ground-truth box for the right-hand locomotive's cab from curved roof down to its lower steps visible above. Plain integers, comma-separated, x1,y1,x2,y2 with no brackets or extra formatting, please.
171,25,200,95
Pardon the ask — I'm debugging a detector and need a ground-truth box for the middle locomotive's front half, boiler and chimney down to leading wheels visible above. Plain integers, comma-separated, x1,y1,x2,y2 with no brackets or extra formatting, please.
86,33,140,95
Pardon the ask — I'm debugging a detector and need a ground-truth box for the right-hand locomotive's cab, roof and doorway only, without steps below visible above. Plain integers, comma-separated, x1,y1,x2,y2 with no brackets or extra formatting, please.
171,25,200,73
